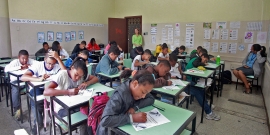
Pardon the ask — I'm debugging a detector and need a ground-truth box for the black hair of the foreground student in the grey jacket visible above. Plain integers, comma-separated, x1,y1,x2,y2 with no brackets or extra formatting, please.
120,69,155,85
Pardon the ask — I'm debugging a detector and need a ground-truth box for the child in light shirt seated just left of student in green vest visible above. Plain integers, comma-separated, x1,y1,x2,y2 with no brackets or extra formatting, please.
169,54,183,79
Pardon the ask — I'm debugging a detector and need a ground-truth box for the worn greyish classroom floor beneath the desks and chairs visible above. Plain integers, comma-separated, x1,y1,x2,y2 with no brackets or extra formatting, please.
0,84,269,135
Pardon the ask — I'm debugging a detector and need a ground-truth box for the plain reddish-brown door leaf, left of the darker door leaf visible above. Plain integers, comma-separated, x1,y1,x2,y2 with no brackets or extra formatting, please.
108,18,128,53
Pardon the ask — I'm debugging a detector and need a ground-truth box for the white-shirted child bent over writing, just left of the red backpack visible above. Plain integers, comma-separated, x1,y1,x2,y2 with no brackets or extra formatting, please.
43,57,98,135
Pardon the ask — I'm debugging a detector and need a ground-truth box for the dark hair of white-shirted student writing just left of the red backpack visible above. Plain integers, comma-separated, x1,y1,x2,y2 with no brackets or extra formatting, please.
70,57,88,80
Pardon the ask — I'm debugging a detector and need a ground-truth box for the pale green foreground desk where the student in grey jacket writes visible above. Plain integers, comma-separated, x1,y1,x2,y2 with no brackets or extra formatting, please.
109,100,196,135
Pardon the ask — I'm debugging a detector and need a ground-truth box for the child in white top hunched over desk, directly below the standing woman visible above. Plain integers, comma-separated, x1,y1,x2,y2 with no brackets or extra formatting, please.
131,49,151,70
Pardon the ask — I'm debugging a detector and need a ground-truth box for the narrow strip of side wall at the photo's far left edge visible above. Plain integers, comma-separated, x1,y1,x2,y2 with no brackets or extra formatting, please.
0,0,11,57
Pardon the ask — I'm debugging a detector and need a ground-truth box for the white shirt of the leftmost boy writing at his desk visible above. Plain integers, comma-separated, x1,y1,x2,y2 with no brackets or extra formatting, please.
5,58,38,82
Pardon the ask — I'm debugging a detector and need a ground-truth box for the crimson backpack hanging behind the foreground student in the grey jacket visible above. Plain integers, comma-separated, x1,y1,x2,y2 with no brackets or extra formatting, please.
87,92,109,135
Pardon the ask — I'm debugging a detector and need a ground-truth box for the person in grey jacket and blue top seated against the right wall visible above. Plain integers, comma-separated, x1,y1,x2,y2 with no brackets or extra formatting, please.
233,44,266,94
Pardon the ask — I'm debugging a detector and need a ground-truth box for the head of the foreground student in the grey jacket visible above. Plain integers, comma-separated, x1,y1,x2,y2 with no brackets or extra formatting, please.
120,69,155,100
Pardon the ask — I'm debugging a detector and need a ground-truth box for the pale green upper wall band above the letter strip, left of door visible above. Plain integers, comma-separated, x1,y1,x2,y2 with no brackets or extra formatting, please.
9,0,114,24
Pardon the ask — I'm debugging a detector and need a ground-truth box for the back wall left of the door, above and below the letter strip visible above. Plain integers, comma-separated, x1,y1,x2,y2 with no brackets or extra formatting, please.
8,0,114,56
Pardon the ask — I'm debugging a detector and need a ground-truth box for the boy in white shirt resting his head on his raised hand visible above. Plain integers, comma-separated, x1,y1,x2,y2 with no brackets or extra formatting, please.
21,52,66,135
